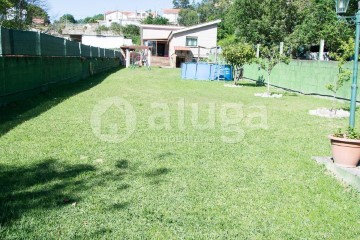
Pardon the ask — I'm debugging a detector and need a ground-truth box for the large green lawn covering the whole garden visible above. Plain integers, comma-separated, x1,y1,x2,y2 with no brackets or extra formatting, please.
0,69,360,239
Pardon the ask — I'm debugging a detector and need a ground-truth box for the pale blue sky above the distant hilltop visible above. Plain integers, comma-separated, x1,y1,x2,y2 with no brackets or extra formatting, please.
47,0,179,20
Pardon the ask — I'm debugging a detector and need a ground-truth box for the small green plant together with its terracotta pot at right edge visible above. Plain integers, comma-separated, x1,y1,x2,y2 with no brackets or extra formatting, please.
329,127,360,167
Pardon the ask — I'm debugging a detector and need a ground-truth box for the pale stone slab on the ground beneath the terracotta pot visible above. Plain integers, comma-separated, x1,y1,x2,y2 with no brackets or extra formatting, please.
312,157,360,192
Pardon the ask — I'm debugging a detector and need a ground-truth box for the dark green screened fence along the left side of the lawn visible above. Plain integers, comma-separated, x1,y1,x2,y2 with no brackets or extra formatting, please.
0,27,121,106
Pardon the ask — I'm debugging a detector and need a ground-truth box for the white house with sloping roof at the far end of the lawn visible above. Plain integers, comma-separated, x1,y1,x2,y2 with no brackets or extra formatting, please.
140,20,221,67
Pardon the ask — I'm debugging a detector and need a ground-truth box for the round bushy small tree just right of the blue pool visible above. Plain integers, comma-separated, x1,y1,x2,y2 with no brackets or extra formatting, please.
222,43,255,81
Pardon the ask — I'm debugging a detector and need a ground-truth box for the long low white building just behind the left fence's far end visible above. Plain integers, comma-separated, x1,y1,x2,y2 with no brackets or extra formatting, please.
82,35,133,49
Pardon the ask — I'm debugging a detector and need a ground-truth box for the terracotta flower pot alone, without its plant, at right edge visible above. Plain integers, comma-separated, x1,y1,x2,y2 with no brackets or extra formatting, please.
329,135,360,167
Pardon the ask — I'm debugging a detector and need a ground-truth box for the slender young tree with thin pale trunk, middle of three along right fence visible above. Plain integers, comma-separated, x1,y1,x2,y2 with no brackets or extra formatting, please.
259,45,290,96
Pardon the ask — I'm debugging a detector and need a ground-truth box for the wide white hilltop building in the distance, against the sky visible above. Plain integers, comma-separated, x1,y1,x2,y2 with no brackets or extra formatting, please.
100,11,157,27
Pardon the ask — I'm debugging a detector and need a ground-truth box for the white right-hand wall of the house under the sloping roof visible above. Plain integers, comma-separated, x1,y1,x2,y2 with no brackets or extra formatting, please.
169,24,217,57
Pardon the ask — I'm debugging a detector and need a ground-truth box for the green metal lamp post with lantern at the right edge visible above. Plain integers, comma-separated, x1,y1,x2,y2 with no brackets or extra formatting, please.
335,0,360,128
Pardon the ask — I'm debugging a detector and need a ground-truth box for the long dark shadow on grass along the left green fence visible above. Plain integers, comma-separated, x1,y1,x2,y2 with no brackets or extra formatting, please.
0,68,119,137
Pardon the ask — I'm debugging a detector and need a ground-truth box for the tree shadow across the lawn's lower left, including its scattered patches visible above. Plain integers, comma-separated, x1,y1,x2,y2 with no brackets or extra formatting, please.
0,156,170,226
